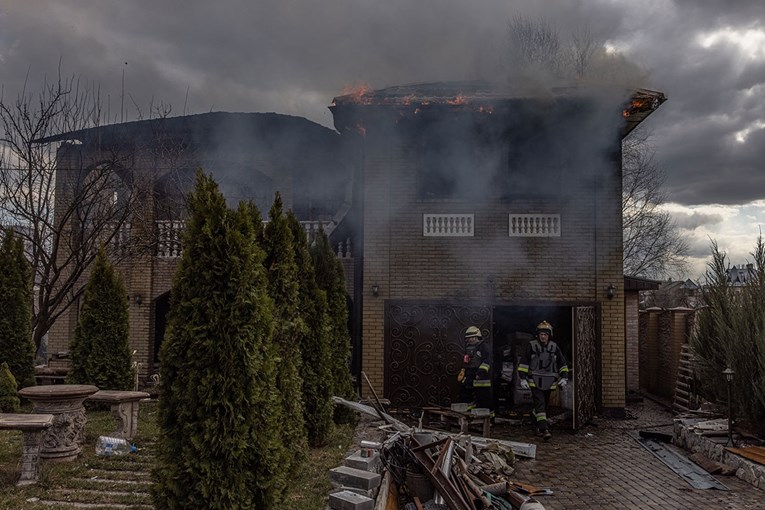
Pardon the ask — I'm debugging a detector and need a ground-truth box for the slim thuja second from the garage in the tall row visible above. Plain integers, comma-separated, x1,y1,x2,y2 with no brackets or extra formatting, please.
287,211,333,446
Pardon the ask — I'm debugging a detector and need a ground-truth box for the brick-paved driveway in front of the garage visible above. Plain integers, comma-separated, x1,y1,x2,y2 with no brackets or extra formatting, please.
491,400,765,510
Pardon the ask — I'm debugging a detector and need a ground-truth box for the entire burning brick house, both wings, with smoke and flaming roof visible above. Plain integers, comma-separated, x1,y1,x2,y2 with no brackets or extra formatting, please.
44,82,665,427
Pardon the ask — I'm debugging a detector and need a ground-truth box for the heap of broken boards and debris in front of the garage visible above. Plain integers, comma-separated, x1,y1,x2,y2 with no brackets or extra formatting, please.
330,397,552,510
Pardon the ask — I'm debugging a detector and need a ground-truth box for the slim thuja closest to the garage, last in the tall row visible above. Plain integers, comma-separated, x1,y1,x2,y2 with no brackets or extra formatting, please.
311,230,354,423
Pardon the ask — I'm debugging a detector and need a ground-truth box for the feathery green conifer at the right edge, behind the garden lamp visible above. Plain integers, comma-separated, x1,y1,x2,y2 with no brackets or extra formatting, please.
691,237,765,427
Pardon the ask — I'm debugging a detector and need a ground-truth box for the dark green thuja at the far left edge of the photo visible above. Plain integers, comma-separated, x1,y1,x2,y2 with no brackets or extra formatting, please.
0,229,35,391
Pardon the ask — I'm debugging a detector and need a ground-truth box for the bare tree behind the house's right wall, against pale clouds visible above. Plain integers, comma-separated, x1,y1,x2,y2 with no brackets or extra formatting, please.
622,129,688,278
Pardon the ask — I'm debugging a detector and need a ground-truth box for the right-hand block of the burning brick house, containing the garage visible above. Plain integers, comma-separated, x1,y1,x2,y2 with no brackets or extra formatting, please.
331,82,665,427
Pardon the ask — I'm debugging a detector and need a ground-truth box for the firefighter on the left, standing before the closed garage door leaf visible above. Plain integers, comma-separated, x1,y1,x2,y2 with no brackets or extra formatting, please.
457,326,494,409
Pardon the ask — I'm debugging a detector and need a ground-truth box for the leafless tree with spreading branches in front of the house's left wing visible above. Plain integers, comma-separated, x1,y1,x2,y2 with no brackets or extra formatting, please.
0,70,152,349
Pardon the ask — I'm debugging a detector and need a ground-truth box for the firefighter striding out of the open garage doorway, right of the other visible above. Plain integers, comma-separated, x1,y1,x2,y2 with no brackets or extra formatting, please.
518,321,568,441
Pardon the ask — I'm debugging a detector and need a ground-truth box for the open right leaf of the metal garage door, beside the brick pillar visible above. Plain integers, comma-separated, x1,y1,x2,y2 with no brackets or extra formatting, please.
572,306,597,430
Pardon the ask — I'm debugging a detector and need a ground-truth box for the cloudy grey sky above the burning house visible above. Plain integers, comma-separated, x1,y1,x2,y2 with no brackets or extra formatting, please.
0,0,765,280
